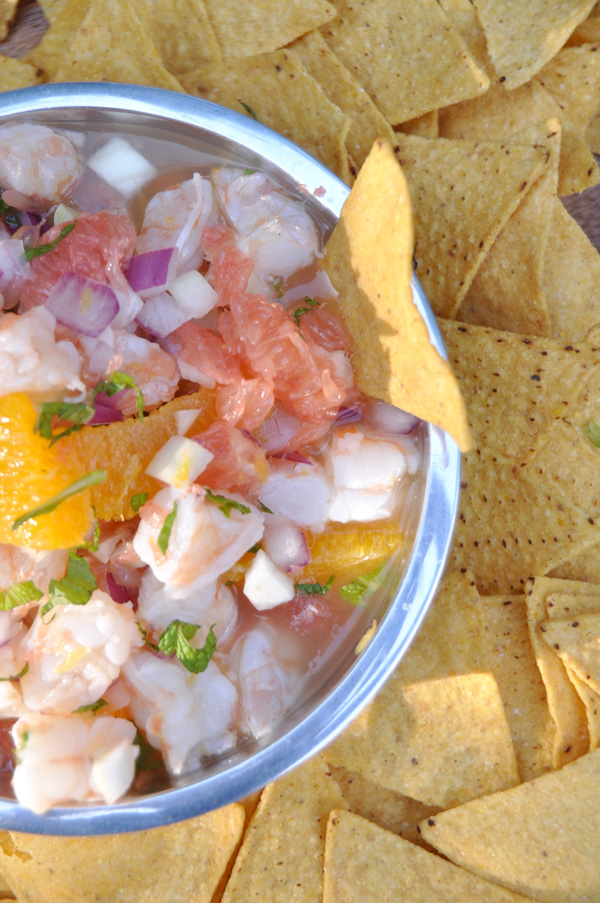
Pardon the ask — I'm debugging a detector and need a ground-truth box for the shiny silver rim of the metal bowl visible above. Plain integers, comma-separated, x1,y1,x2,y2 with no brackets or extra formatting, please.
0,82,460,836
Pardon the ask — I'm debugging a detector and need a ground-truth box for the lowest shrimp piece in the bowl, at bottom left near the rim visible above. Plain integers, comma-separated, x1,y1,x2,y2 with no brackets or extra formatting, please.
12,713,139,814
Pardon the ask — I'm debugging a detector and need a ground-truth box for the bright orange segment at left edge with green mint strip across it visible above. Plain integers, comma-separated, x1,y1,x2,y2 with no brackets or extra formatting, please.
0,392,92,549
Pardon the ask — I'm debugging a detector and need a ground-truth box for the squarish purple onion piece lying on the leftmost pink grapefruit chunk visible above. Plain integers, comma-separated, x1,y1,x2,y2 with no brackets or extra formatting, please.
46,273,119,338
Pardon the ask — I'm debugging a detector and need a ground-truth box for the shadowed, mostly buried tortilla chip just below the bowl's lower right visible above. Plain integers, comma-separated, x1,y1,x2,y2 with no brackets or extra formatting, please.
331,765,440,845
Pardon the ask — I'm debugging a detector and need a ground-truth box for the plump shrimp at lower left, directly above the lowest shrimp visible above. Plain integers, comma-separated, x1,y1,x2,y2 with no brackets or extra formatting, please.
21,590,143,713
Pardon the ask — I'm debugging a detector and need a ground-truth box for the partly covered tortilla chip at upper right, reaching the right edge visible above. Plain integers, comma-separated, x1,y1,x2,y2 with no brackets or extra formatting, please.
440,79,600,196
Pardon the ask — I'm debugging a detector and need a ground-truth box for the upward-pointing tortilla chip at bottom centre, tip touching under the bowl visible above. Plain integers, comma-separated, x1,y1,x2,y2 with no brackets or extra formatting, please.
223,756,346,903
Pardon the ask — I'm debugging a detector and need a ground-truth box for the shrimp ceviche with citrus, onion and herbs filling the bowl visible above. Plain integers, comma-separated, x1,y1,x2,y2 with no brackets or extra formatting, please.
0,123,422,812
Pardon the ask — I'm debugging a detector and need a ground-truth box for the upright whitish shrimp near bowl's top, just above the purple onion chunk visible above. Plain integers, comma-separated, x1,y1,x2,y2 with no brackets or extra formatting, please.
136,172,217,273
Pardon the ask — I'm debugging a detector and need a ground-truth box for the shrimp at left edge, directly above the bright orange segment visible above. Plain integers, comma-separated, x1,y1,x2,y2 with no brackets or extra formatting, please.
0,307,85,401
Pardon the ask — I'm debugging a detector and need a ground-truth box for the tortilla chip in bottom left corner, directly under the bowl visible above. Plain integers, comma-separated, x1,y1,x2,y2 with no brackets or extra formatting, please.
0,804,244,903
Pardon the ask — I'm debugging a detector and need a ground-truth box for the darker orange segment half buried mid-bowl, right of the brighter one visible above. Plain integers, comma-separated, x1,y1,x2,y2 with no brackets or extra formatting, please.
56,388,216,520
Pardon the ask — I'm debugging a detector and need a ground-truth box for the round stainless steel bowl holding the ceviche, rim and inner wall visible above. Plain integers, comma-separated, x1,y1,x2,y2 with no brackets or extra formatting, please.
0,83,460,835
